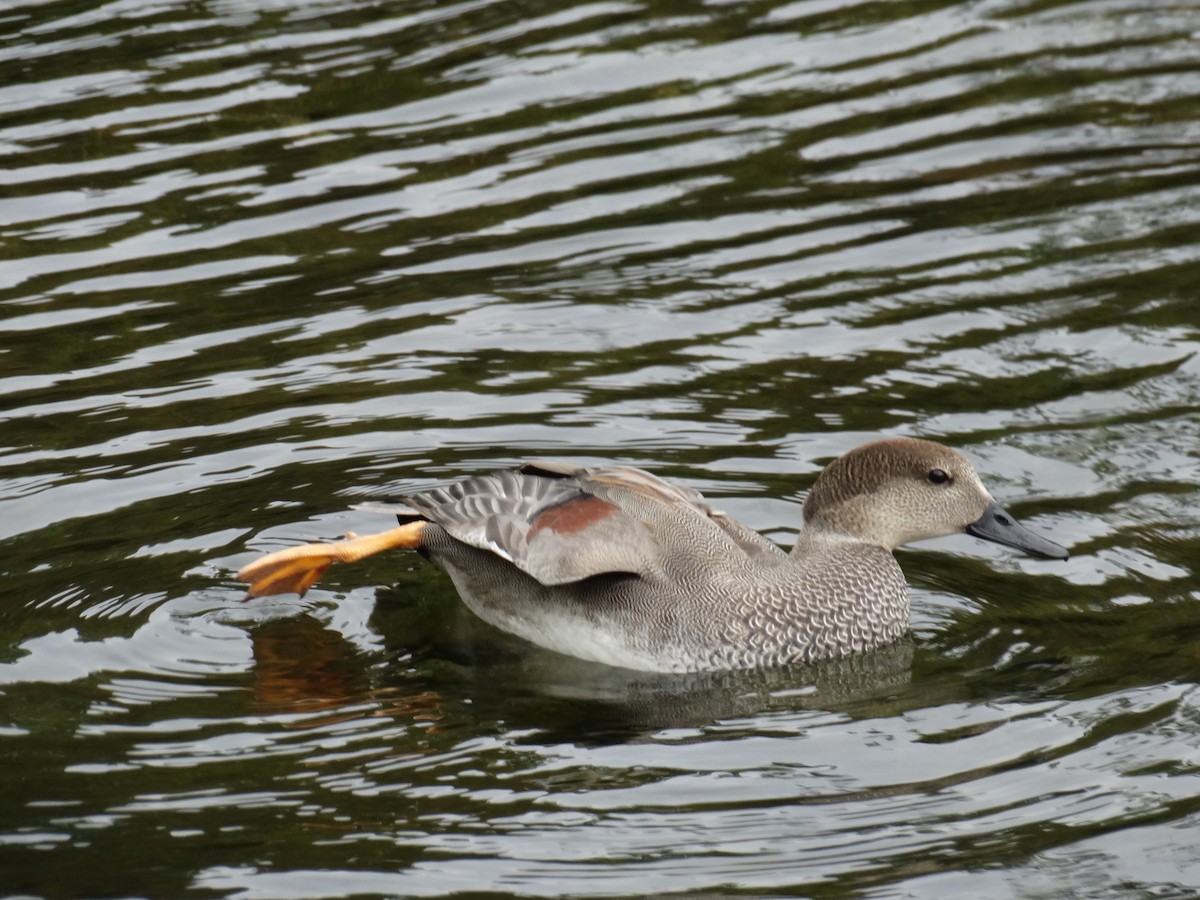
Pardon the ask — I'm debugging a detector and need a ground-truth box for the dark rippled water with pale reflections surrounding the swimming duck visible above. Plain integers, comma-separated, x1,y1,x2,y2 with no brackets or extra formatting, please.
0,0,1200,900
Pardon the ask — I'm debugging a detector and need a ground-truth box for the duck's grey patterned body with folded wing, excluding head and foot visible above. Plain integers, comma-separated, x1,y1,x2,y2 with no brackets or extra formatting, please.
388,463,908,672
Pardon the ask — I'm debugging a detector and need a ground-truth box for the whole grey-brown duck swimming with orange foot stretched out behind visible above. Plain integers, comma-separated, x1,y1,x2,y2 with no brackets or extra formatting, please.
238,437,1068,672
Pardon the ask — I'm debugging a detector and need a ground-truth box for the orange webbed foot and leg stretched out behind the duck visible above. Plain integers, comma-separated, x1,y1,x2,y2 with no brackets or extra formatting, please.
238,522,428,596
